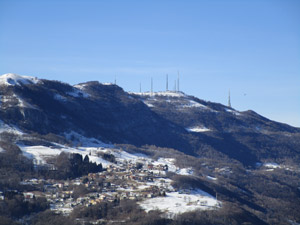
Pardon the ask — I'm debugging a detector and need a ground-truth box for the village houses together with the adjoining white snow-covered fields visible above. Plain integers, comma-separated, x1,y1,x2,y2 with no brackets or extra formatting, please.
7,146,221,220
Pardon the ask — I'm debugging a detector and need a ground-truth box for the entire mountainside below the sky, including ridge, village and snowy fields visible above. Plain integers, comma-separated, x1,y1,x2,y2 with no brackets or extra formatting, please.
0,74,300,224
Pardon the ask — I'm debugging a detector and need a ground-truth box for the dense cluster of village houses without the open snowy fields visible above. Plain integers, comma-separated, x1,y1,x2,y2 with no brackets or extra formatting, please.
11,157,174,214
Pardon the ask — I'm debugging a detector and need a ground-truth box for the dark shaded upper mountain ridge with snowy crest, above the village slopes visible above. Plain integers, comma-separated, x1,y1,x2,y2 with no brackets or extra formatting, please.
0,74,300,166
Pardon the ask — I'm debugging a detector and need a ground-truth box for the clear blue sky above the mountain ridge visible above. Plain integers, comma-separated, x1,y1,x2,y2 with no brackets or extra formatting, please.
0,0,300,127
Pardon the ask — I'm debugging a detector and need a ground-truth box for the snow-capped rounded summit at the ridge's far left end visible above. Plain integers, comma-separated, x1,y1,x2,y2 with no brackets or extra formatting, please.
0,73,39,86
